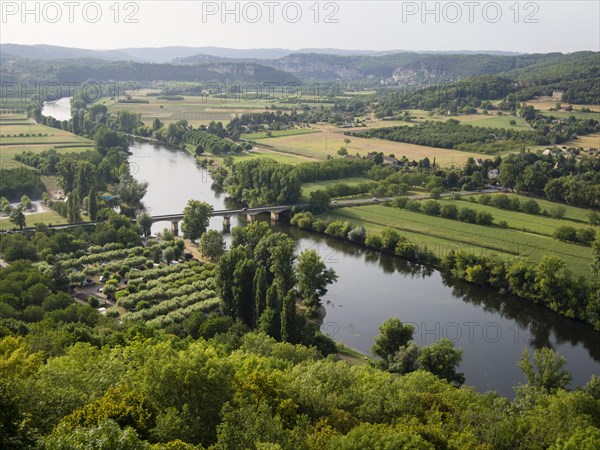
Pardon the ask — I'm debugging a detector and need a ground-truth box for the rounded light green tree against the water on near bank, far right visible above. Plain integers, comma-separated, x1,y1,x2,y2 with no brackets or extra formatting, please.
517,347,572,392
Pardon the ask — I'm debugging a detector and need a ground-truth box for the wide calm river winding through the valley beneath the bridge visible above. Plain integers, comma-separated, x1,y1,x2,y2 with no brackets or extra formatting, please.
43,97,600,397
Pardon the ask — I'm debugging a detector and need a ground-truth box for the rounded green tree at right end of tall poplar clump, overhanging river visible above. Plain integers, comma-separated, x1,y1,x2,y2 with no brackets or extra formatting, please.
296,250,337,308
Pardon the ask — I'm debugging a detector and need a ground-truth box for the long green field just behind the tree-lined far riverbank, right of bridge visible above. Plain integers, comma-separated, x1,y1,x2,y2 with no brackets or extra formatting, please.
323,205,593,279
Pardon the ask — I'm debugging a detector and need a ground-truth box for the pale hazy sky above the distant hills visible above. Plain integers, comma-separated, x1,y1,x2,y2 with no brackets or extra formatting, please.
0,0,600,53
